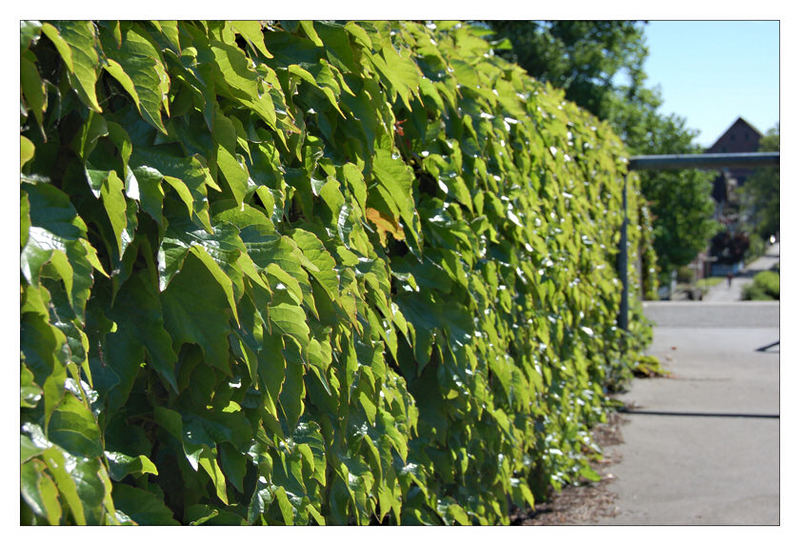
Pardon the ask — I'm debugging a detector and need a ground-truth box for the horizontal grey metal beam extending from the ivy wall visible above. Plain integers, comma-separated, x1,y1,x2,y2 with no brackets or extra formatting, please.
628,152,781,171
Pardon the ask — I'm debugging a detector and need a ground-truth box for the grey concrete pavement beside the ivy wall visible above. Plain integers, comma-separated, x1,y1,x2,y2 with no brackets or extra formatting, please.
598,301,779,525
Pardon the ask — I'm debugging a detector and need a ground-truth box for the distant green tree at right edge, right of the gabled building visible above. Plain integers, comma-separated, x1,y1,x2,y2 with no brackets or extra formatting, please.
739,125,781,239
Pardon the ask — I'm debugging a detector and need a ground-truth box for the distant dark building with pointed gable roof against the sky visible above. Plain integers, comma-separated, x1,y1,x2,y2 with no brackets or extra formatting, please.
706,117,763,207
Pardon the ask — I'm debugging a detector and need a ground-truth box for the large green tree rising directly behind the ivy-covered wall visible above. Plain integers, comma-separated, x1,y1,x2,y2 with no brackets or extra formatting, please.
488,21,719,282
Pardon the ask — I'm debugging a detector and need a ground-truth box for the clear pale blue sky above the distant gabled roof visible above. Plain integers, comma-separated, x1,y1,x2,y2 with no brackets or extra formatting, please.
644,21,779,146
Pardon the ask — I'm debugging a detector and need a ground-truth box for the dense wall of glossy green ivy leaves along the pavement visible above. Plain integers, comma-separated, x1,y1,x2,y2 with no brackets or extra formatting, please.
20,21,649,525
